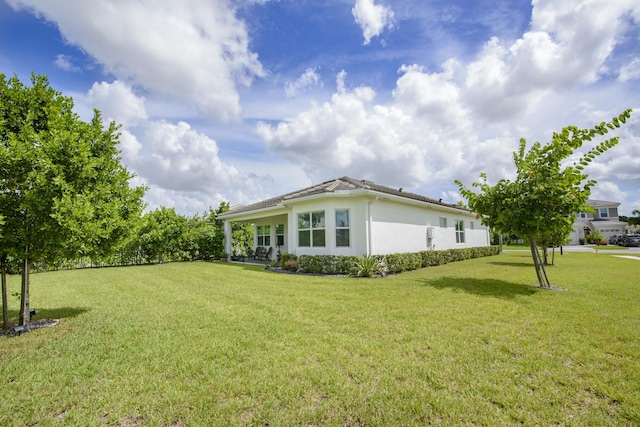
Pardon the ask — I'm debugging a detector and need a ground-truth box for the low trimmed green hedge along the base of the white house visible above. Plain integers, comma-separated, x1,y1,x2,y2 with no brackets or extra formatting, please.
292,246,500,275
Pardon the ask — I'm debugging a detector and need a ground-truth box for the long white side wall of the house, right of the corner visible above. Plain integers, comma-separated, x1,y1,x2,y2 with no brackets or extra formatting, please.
370,199,490,255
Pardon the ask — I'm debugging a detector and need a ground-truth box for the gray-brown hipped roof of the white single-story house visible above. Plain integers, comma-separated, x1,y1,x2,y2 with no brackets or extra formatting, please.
220,176,467,217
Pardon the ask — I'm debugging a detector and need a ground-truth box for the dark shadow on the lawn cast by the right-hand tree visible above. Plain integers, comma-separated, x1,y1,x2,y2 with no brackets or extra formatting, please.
422,277,538,298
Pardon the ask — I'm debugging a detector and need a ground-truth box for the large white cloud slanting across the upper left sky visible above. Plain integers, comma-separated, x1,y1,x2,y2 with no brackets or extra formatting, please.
10,0,265,122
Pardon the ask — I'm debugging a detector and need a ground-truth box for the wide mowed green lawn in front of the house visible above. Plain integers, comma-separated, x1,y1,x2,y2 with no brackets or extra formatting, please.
0,252,640,426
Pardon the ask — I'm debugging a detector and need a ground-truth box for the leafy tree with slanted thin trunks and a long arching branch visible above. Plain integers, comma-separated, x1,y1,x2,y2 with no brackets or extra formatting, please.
455,109,631,288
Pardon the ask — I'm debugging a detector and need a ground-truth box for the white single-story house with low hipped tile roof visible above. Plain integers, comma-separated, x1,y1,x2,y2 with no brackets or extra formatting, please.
218,177,490,258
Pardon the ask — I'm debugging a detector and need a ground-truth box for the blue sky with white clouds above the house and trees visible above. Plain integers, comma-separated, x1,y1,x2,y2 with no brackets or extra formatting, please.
0,0,640,215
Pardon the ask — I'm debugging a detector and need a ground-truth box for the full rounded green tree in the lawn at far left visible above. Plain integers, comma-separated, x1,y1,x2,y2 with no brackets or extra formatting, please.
0,74,145,324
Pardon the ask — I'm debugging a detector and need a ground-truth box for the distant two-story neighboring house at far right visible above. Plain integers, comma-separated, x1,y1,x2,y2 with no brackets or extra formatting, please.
569,200,628,245
